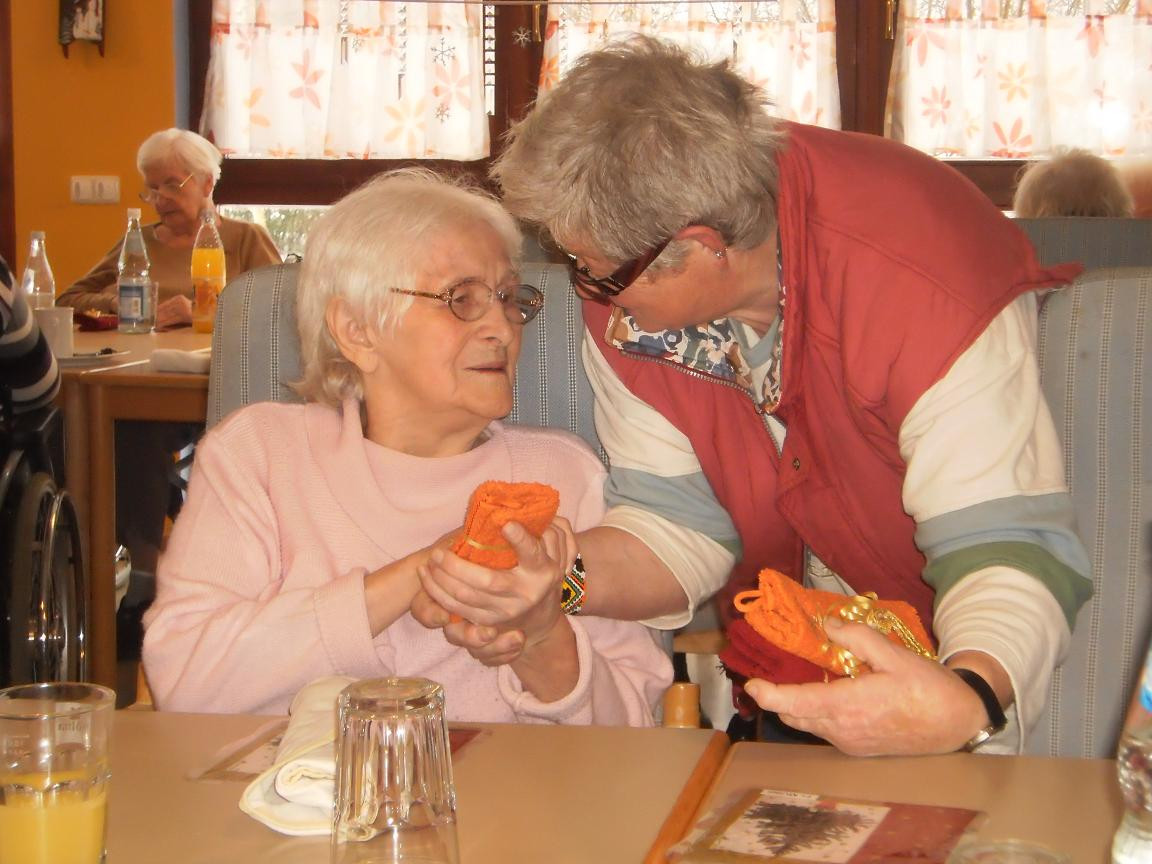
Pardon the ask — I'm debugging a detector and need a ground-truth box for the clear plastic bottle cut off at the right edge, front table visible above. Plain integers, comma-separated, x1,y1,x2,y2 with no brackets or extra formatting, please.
1112,645,1152,864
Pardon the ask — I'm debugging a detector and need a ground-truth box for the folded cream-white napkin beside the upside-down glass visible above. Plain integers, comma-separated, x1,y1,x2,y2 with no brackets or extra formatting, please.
240,676,356,836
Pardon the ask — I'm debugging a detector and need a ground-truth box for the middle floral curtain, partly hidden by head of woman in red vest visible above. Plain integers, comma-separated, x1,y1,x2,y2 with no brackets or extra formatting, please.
540,0,840,128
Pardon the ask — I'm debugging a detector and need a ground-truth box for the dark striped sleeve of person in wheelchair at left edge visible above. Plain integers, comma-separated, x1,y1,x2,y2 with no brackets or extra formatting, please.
0,258,60,419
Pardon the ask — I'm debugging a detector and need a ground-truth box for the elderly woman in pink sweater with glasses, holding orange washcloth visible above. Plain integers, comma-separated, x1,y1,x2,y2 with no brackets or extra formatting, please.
144,169,670,726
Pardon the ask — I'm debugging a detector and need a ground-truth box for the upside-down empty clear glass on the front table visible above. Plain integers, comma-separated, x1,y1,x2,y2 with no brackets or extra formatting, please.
332,679,460,864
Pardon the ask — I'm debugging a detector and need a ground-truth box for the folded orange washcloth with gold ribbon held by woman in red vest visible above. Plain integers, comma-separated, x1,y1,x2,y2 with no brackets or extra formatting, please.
735,569,932,675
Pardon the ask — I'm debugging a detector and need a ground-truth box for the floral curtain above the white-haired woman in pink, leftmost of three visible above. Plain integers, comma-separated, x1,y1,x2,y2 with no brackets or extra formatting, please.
200,0,488,159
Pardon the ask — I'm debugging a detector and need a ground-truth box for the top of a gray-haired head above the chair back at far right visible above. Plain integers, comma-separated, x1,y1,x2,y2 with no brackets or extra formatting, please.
1013,147,1132,219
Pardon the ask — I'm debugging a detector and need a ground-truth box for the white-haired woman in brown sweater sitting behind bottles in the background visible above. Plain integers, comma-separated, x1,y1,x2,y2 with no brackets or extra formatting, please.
56,129,280,329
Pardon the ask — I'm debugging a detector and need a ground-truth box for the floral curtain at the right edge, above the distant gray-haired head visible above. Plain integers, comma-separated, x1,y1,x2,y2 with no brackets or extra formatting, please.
887,0,1152,159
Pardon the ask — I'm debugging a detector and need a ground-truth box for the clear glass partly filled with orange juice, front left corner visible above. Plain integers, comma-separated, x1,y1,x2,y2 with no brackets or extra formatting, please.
0,683,116,864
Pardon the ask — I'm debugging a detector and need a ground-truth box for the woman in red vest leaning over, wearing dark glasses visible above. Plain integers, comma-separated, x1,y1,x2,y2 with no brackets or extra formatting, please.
430,38,1092,755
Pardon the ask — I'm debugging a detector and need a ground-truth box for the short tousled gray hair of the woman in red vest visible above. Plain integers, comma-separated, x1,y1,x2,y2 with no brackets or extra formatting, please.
492,37,783,265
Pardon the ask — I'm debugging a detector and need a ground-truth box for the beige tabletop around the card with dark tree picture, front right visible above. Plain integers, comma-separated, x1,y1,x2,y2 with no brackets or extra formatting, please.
686,743,1122,864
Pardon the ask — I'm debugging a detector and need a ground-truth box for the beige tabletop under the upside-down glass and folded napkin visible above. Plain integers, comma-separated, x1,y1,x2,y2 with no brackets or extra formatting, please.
108,711,727,864
